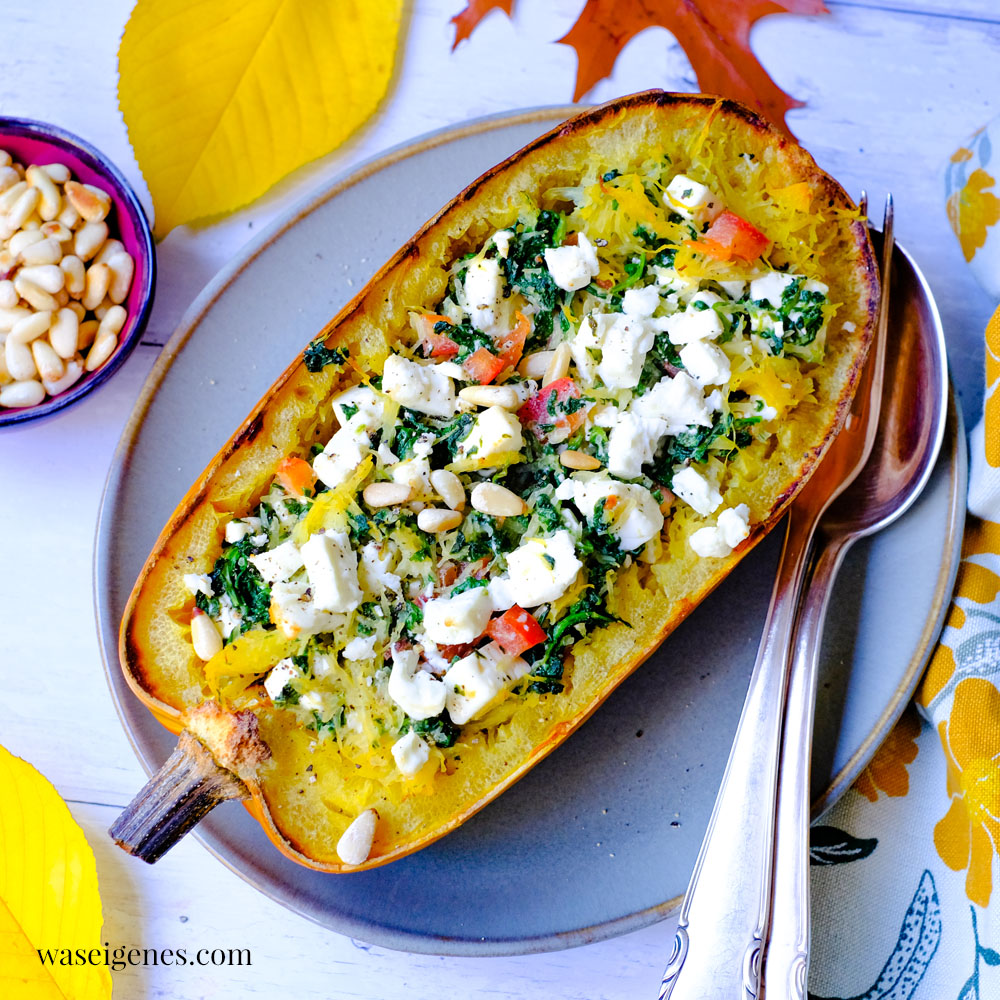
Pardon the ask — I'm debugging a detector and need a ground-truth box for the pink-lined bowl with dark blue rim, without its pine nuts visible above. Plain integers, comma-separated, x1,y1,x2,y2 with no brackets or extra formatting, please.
0,117,156,427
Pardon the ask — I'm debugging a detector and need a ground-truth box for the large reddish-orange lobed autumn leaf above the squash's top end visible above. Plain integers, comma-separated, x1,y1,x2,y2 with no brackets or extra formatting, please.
556,0,827,132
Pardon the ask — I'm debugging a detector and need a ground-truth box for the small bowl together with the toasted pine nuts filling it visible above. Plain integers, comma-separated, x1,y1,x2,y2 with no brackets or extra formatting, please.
0,118,156,427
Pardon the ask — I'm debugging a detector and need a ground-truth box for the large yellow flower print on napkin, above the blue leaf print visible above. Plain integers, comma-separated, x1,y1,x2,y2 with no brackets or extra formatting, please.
934,677,1000,907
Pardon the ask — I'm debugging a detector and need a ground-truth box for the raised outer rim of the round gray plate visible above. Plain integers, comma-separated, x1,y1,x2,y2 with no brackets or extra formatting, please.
93,105,967,957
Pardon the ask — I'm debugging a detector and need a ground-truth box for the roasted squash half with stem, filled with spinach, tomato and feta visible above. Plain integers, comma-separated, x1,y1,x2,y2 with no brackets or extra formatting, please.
112,92,877,872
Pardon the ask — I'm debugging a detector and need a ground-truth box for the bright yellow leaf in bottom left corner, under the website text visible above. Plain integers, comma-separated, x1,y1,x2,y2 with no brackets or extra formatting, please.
0,747,111,1000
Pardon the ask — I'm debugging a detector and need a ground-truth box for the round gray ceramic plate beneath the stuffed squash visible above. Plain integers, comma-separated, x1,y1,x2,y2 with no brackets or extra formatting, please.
95,109,965,955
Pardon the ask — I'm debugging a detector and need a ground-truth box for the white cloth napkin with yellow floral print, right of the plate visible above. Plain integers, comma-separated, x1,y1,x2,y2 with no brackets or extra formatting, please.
809,141,1000,1000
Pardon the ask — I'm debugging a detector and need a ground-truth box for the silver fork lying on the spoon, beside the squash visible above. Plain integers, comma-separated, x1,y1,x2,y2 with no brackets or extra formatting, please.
660,196,891,1000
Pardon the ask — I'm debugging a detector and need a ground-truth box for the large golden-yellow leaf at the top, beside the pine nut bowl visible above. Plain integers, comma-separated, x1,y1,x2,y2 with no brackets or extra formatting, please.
118,0,403,236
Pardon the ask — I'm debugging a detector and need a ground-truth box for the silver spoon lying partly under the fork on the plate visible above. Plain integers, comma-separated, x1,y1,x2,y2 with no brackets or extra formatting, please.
758,223,948,1000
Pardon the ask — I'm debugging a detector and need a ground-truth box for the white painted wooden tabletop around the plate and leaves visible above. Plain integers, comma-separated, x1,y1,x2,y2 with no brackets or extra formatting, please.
0,0,1000,1000
